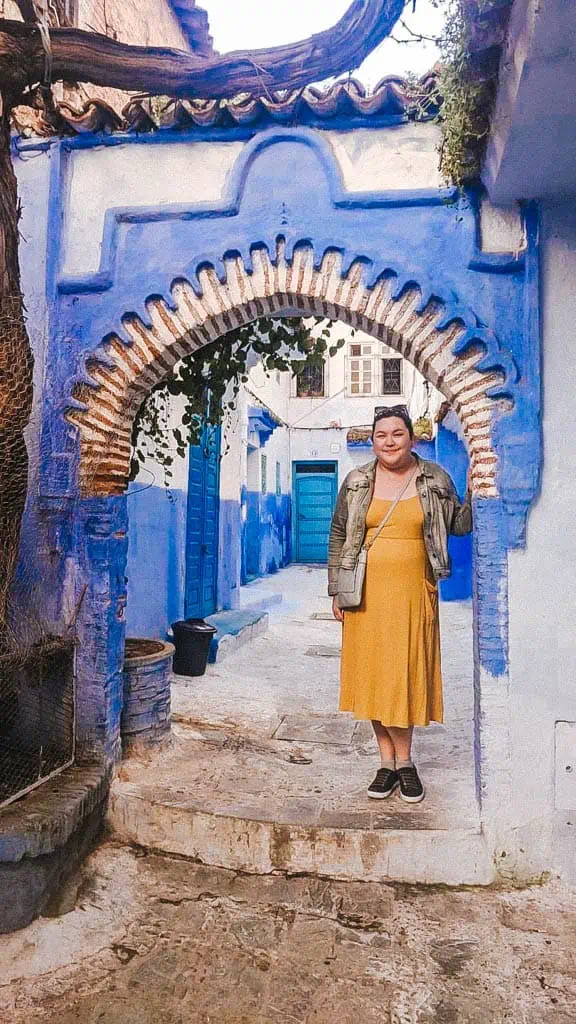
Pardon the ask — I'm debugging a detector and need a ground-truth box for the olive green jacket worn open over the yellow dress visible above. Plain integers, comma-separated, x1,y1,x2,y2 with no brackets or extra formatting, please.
328,453,472,595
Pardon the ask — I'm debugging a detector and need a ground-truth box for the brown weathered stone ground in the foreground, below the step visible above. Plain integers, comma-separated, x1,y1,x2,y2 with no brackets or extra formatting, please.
0,843,576,1024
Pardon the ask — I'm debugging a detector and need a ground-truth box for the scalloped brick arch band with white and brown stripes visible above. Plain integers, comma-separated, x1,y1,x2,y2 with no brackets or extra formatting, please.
66,239,517,498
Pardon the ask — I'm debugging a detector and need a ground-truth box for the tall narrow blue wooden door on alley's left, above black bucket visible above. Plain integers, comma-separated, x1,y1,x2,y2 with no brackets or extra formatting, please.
184,426,220,618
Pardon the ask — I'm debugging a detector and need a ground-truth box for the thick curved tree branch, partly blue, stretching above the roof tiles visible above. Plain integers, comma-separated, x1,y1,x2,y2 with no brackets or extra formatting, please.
0,0,405,99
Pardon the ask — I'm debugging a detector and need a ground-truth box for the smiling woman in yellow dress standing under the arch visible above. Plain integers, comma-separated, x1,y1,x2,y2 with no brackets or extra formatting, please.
328,406,472,803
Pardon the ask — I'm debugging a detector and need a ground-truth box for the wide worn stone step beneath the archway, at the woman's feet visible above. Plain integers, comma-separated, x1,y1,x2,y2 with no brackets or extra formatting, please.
109,725,487,886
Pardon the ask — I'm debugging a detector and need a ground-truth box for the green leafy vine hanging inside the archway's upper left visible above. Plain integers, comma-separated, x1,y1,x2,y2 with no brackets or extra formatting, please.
130,316,342,486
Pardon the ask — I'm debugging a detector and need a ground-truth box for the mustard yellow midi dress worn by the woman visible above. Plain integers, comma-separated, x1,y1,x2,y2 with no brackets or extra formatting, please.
340,497,443,728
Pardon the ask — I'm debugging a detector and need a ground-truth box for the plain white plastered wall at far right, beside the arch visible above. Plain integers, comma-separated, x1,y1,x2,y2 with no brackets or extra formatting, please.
507,203,576,881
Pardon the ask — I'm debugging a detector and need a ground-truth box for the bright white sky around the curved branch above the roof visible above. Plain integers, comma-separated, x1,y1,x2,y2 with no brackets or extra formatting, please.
199,0,443,87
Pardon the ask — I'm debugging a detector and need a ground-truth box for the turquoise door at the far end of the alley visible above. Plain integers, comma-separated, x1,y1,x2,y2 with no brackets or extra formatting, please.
293,462,338,562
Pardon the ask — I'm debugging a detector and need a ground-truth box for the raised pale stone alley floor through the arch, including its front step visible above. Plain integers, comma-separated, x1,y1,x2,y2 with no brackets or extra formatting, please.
111,565,479,884
